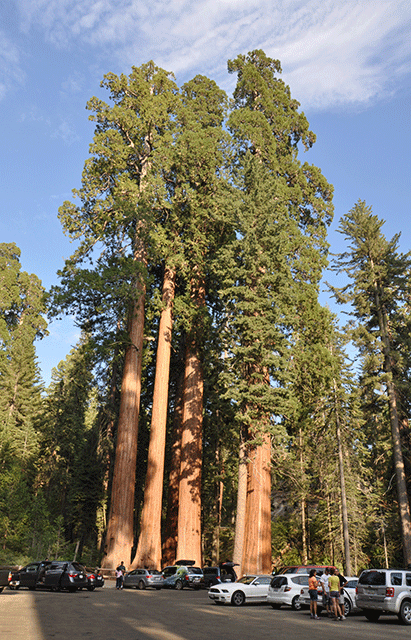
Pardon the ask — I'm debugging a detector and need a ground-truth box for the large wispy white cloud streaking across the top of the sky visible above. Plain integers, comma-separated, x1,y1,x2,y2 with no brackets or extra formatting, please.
16,0,411,108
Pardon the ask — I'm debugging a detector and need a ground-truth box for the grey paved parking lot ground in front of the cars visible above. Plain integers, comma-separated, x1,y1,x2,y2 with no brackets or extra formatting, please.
0,584,411,640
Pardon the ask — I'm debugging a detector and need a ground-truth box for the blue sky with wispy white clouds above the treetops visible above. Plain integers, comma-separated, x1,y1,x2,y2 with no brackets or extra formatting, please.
0,0,411,383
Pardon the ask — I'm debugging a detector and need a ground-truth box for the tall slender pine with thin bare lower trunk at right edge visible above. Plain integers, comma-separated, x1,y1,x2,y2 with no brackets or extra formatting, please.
333,200,411,565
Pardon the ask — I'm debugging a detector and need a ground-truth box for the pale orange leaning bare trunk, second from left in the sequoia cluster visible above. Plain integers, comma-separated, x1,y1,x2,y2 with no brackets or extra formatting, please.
132,267,175,569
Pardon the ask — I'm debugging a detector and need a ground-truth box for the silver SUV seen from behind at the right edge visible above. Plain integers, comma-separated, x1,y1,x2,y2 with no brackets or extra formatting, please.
357,569,411,625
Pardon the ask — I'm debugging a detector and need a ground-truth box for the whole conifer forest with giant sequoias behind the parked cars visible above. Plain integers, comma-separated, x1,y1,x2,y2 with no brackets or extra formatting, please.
0,50,411,575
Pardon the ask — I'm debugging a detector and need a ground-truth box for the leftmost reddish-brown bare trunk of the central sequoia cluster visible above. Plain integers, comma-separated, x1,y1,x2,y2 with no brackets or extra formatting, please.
102,243,146,568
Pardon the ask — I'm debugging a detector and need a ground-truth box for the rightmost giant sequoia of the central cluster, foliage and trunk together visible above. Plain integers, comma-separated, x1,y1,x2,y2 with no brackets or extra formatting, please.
223,50,332,571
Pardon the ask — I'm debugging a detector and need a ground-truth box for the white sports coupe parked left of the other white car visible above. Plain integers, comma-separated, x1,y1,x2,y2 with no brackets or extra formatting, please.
208,574,273,607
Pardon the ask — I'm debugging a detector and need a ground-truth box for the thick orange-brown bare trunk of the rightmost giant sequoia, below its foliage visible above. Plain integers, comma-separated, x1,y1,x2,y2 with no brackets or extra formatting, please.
242,434,271,573
